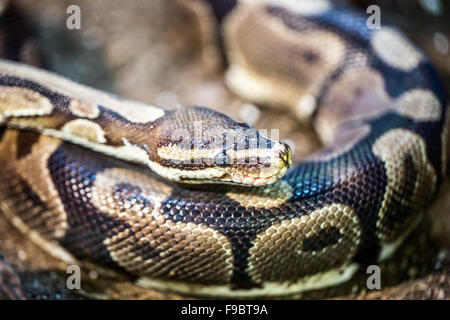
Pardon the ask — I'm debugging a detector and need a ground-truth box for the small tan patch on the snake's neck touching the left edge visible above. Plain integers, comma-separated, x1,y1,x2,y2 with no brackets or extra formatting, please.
0,86,53,118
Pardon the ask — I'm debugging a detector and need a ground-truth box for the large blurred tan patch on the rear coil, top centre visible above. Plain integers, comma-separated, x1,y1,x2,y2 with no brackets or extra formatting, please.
224,3,346,109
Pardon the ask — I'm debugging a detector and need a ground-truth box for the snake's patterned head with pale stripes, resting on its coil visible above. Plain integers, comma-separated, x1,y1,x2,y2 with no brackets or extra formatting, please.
147,107,292,186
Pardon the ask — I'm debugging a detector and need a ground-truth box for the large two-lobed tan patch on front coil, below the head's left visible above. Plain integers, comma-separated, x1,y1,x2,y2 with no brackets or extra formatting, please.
91,168,233,283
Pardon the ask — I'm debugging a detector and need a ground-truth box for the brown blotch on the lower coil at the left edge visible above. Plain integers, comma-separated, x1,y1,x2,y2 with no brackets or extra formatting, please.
0,129,68,240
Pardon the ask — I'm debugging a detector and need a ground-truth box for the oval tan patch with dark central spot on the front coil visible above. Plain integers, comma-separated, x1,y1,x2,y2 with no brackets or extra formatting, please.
247,204,361,283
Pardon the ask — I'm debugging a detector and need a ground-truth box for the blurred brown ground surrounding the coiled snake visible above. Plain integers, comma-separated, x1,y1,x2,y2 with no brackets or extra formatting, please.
0,0,450,299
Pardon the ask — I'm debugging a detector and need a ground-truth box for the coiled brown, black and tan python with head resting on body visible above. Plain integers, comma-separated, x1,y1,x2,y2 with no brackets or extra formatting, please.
0,0,448,298
